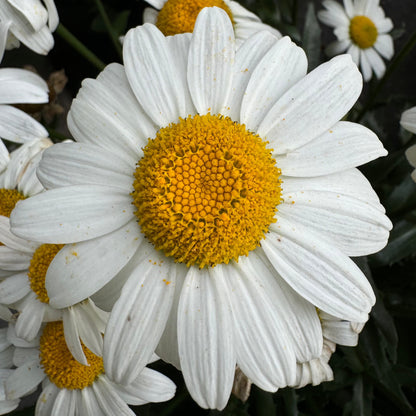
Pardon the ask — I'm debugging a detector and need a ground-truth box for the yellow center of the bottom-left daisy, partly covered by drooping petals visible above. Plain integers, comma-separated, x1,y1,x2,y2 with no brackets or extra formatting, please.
40,321,104,390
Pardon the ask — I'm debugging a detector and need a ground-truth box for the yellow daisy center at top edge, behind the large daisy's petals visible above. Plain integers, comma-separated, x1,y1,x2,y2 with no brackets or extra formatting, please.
156,0,233,36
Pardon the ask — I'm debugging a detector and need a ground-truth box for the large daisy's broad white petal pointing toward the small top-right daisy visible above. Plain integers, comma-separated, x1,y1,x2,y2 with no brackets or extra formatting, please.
257,55,362,154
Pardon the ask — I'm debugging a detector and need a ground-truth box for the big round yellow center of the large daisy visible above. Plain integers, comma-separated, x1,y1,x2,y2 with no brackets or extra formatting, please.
132,114,281,268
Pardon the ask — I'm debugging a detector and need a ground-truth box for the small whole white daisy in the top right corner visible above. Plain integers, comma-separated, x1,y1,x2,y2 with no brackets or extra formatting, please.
318,0,394,81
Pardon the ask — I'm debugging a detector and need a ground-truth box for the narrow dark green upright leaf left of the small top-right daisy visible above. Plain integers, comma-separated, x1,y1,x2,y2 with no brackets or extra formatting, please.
302,3,322,71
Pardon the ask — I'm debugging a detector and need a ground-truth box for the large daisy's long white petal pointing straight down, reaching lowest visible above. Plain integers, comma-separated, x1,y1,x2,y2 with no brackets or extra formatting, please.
178,266,236,410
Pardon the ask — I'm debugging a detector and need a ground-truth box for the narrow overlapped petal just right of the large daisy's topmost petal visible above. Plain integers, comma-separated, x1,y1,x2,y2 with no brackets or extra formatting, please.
224,31,276,122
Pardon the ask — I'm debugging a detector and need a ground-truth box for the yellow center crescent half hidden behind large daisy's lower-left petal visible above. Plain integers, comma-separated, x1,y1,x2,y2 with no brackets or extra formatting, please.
27,244,64,303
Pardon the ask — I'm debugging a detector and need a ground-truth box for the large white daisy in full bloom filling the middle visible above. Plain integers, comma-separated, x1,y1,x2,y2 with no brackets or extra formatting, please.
11,8,392,409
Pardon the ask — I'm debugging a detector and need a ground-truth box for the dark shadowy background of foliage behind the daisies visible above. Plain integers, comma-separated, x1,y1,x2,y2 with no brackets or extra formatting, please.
0,0,416,416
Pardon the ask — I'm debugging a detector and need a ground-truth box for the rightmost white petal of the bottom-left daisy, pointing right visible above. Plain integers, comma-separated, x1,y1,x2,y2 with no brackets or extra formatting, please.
116,367,176,405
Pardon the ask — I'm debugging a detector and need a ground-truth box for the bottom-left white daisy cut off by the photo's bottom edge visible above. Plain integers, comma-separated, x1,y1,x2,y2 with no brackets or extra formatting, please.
0,322,175,416
